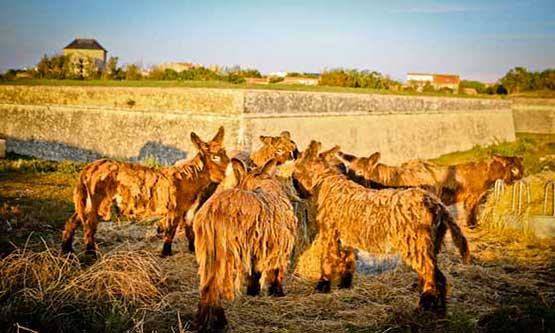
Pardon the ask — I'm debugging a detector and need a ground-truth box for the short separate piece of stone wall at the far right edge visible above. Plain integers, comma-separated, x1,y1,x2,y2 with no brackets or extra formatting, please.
512,98,555,134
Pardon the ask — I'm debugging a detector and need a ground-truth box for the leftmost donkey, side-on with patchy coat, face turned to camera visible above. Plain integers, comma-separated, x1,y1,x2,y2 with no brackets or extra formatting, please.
58,127,229,256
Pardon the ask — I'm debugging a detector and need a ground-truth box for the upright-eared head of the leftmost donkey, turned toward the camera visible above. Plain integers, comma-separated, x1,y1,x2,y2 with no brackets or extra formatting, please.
191,126,229,183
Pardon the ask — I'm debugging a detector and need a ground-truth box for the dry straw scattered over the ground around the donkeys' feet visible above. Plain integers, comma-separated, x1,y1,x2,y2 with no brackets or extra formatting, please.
0,198,555,332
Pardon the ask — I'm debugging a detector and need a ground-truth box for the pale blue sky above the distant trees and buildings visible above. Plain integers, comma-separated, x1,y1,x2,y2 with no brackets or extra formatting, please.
0,0,555,82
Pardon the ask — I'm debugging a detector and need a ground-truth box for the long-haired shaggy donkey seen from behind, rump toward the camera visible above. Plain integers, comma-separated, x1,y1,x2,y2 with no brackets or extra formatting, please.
193,159,297,332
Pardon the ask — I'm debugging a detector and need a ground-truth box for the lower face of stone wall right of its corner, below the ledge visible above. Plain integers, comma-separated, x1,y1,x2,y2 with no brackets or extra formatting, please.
247,110,515,164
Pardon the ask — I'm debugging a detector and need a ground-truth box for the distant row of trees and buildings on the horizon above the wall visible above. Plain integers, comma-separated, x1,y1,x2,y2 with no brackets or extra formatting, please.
0,38,552,95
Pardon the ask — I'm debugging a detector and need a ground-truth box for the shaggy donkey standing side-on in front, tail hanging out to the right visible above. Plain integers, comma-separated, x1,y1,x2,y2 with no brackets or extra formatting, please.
293,141,470,314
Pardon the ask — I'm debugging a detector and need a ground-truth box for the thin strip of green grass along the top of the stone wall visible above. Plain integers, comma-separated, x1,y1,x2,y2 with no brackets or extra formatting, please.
0,79,502,98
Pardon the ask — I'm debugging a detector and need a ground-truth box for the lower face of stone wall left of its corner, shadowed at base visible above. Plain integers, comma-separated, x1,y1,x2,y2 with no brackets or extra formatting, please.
0,104,238,164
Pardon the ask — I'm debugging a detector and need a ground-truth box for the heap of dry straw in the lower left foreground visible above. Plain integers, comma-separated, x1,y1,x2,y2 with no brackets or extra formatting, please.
0,241,166,332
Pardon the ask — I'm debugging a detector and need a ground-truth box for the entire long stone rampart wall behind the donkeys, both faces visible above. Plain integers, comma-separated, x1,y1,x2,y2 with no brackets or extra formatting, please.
0,86,515,163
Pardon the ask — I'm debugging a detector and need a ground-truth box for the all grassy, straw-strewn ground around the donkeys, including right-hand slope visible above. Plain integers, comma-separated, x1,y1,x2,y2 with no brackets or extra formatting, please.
0,134,555,332
